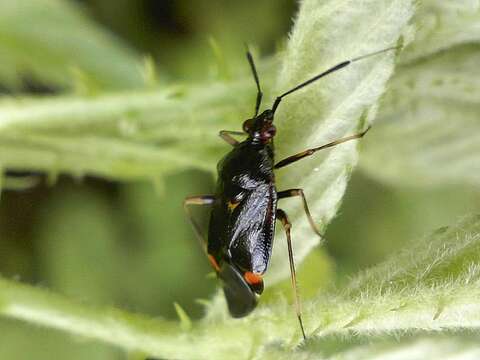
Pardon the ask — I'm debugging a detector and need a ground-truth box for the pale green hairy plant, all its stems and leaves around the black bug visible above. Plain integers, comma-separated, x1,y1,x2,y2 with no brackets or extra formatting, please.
0,0,480,359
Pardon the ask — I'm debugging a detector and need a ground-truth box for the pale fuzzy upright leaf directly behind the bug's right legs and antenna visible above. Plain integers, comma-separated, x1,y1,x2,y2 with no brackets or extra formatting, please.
268,0,413,281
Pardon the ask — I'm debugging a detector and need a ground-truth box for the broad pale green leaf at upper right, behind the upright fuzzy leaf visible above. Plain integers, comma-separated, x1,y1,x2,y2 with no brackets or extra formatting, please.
361,0,480,187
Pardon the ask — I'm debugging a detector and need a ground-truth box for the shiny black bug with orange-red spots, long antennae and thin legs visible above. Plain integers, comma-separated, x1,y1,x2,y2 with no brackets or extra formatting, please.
184,47,397,338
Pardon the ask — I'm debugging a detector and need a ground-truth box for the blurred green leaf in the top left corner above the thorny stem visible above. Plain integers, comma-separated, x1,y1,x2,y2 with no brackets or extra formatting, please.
0,0,143,89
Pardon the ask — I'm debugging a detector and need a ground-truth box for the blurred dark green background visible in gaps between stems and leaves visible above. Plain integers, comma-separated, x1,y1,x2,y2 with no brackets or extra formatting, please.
0,0,480,360
